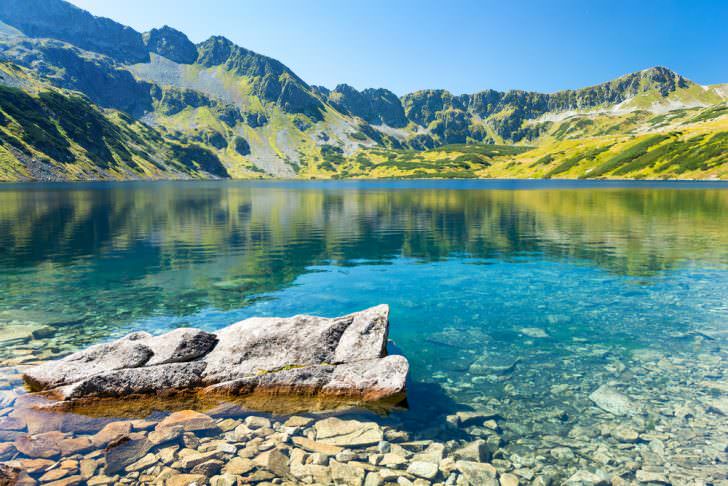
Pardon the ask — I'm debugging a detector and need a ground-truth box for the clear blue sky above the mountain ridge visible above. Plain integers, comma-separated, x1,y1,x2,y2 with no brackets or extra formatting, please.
71,0,728,95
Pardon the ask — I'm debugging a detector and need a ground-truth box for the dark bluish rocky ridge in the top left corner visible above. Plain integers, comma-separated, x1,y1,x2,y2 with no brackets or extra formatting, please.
0,0,149,63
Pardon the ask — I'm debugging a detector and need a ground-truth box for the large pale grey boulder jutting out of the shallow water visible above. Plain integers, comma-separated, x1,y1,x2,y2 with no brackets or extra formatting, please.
24,305,409,401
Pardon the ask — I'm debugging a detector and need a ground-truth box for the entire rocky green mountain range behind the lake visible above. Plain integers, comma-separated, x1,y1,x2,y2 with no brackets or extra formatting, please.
0,0,728,181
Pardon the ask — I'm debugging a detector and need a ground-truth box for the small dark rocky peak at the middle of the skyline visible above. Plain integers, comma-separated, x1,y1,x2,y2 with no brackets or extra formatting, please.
322,84,407,128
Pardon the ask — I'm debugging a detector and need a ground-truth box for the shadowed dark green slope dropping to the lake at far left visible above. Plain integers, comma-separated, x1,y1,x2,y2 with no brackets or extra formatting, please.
0,63,228,180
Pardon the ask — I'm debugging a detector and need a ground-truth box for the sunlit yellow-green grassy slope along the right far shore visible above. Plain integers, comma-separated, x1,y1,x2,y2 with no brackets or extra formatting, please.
334,104,728,179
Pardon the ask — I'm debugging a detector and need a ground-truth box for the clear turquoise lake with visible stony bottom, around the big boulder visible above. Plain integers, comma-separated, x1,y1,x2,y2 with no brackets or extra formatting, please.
0,181,728,486
